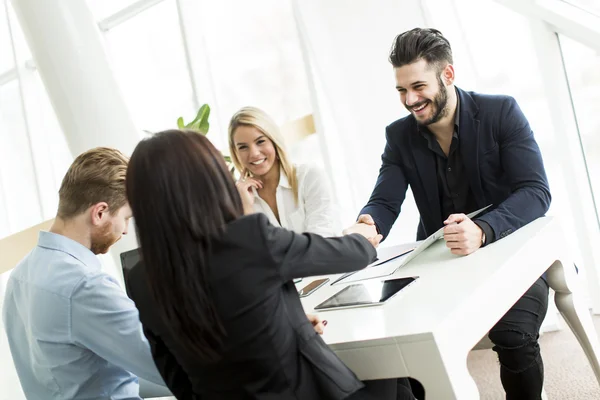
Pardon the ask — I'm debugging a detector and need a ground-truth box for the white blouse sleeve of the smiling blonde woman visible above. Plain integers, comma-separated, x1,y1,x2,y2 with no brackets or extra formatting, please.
301,166,340,237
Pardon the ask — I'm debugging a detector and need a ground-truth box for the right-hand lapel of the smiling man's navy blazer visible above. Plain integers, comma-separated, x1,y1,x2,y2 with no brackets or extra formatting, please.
458,89,487,208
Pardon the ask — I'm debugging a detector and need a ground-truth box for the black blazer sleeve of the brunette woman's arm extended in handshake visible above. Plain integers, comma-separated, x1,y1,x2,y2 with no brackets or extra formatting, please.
259,216,377,282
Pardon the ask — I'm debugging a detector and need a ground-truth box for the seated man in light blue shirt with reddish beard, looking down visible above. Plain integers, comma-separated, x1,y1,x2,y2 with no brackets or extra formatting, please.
3,148,169,400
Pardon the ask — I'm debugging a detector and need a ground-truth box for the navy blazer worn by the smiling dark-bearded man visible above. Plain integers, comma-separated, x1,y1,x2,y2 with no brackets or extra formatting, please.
361,88,551,240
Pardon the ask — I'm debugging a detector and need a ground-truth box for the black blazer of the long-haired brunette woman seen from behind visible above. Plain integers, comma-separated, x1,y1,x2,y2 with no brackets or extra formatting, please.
127,214,376,400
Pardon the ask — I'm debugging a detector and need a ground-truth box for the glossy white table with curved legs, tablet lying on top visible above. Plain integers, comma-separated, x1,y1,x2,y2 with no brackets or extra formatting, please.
298,217,600,400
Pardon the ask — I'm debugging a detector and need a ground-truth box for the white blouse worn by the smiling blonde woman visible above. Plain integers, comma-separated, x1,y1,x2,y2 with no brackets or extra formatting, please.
252,164,340,237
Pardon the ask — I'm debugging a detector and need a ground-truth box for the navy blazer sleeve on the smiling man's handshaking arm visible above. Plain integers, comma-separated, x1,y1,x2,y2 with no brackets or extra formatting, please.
360,126,408,239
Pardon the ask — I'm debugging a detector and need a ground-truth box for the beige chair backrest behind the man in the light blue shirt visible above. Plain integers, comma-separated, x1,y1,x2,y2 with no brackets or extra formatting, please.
0,219,54,274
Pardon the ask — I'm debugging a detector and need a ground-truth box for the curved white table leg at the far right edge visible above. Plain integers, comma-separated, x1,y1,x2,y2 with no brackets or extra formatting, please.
547,261,600,384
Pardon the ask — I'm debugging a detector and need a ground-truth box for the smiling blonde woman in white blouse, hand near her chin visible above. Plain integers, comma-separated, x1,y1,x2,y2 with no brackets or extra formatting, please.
229,107,339,237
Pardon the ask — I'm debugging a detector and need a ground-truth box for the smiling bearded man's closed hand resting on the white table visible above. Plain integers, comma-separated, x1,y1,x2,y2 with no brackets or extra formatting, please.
444,214,483,256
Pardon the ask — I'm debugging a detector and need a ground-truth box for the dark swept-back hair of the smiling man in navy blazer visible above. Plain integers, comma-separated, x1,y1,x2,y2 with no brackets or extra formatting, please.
390,28,453,70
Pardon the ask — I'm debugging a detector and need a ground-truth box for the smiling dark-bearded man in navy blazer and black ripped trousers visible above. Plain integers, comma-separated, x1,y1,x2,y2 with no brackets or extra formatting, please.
357,28,551,400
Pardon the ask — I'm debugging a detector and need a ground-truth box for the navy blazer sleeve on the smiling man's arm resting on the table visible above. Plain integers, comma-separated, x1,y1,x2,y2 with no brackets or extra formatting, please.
477,97,551,239
